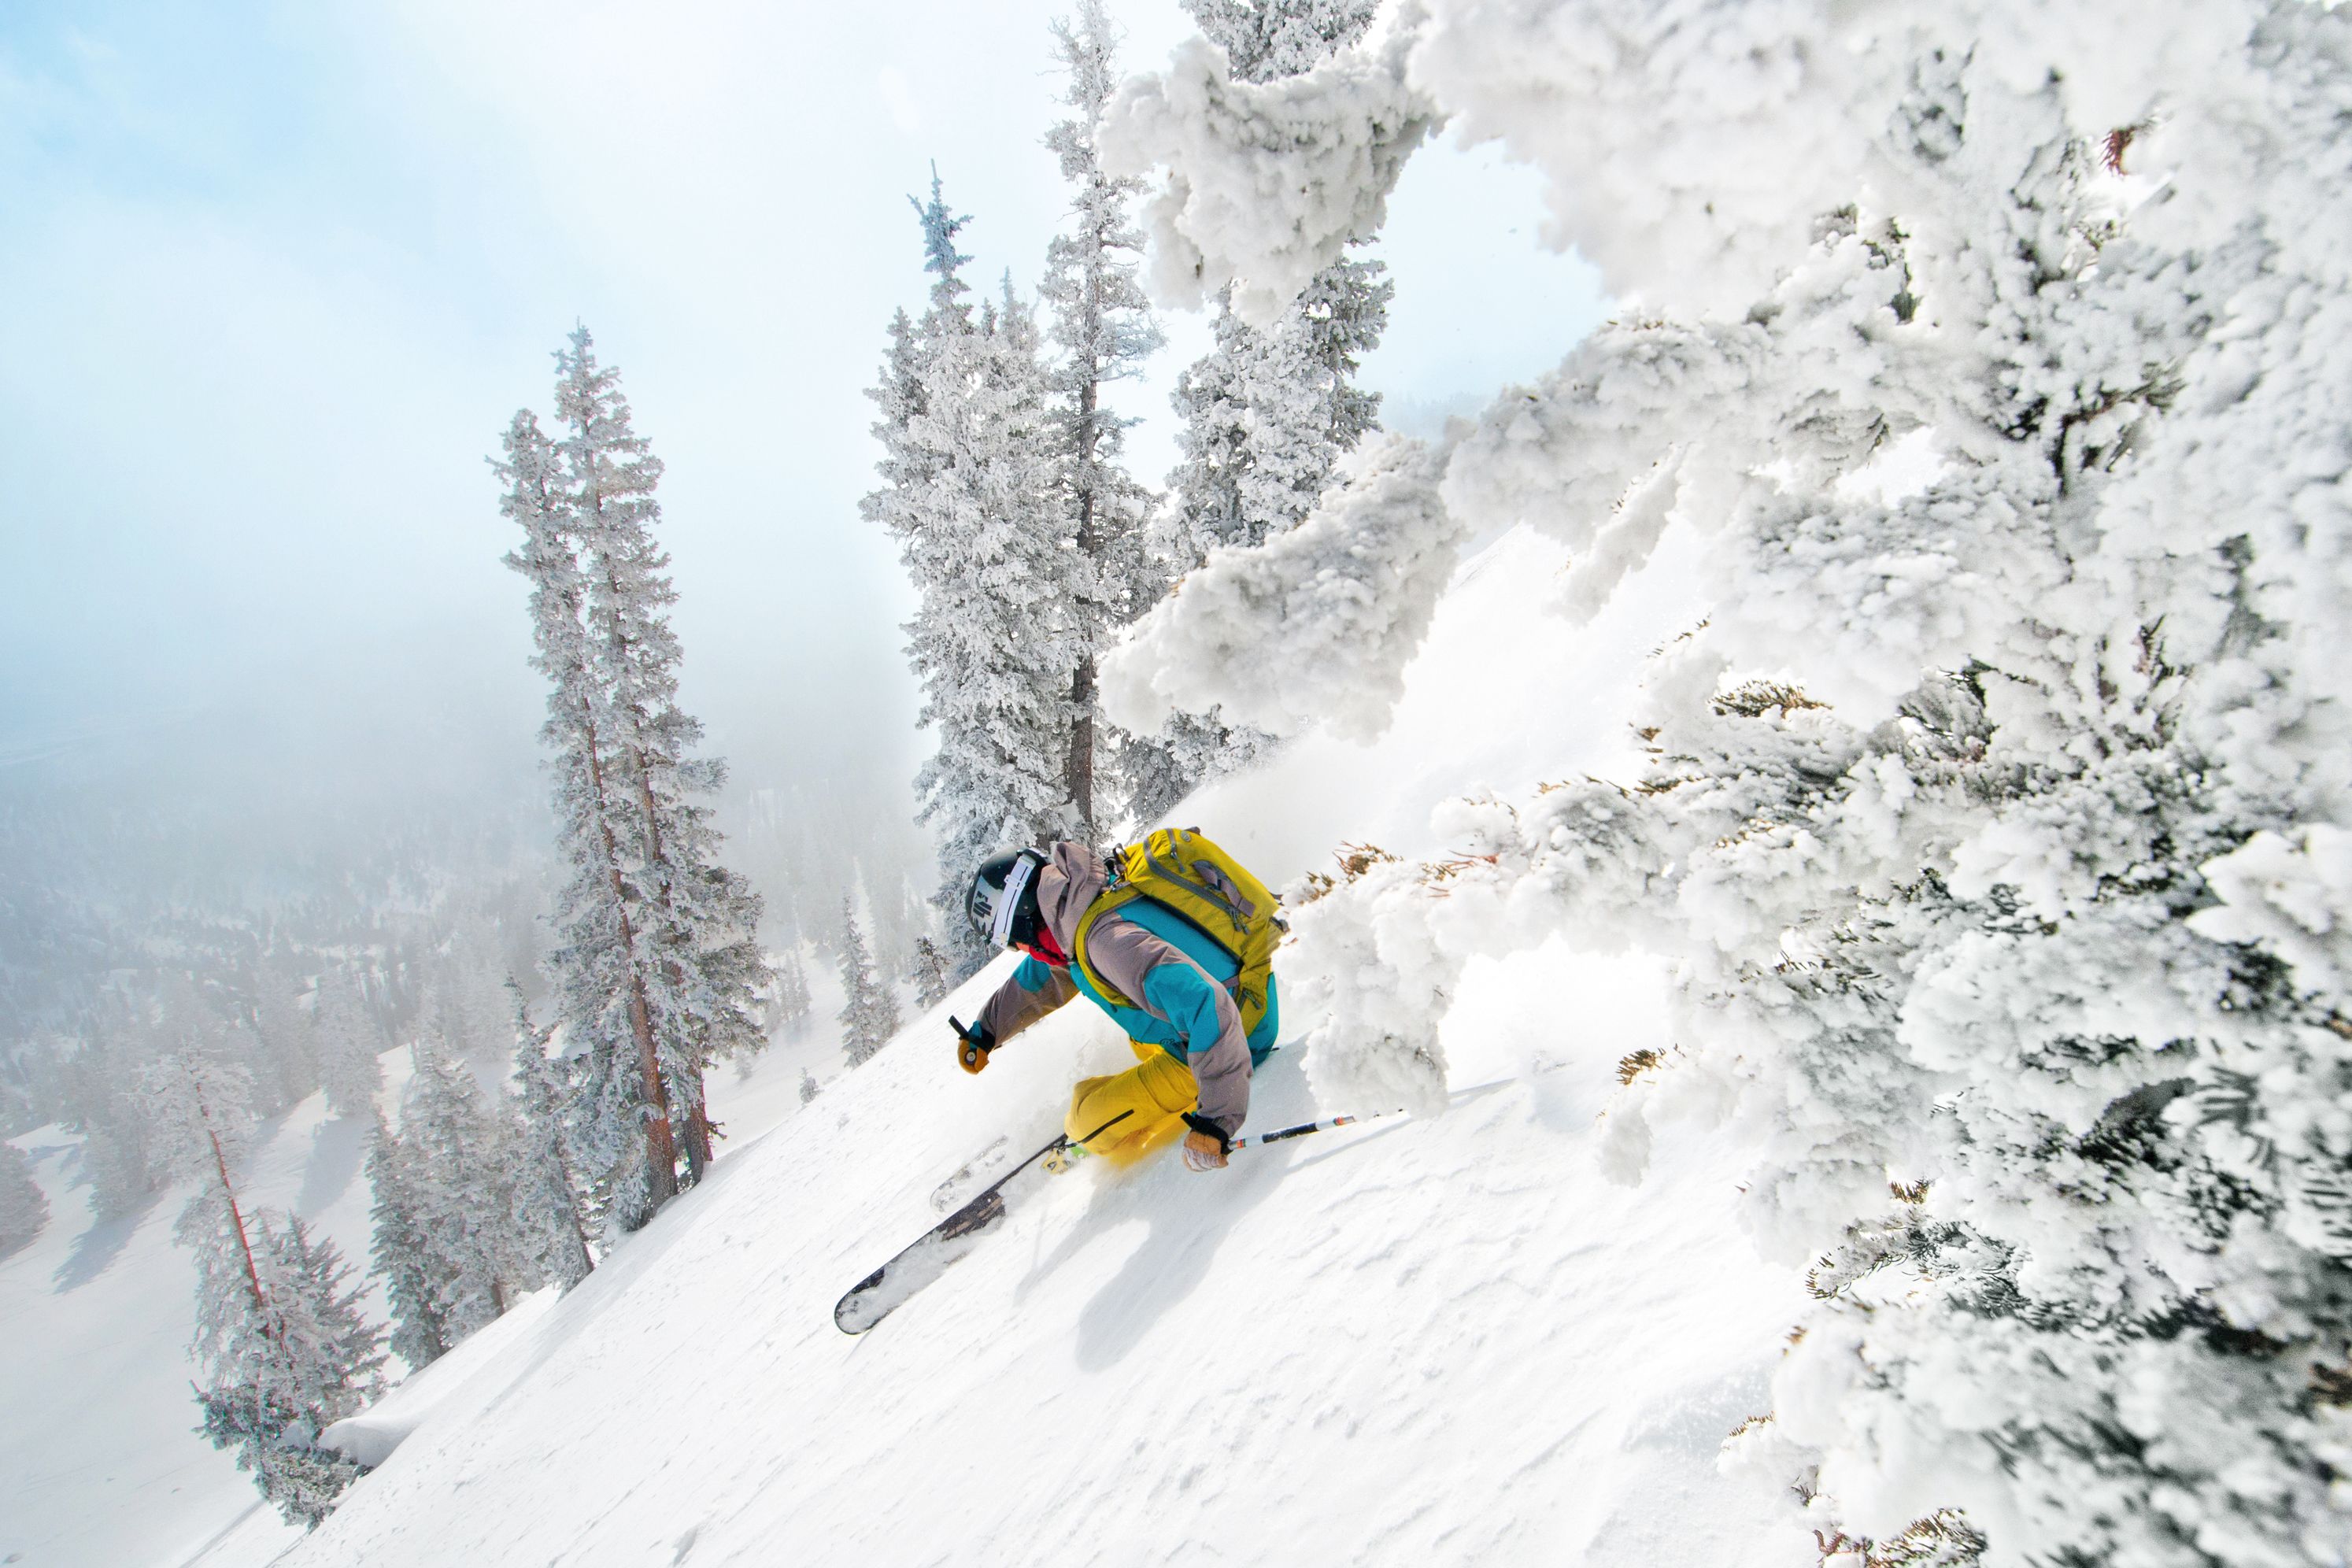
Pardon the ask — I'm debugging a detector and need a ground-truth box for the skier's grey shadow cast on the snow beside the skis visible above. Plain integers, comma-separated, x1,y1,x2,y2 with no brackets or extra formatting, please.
1019,1149,1289,1373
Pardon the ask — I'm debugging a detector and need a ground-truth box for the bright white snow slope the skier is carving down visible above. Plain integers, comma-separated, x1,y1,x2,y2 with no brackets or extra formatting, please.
270,522,1811,1568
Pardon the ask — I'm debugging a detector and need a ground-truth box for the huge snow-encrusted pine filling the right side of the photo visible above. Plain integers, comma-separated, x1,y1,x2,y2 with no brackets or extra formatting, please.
1100,0,2352,1568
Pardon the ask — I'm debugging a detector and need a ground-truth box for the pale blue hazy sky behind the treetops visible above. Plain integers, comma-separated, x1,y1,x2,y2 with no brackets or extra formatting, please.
0,0,1602,823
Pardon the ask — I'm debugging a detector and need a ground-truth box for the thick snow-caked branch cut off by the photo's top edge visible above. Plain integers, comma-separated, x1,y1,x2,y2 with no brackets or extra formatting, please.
1407,0,2249,315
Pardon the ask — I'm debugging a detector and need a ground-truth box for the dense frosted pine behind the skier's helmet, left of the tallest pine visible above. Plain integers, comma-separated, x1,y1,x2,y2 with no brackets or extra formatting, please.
861,174,1079,973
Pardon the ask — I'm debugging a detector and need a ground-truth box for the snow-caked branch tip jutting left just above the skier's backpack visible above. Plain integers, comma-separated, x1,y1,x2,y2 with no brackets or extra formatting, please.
1103,437,1463,738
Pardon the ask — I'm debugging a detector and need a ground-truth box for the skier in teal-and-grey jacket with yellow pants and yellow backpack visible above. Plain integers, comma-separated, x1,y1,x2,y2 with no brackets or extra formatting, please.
957,830,1279,1170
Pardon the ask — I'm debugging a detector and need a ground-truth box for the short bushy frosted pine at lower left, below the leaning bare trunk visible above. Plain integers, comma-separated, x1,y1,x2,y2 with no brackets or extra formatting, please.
195,1213,383,1528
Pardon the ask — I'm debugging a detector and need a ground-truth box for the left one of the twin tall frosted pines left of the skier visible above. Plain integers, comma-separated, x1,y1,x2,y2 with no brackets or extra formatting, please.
494,412,678,1230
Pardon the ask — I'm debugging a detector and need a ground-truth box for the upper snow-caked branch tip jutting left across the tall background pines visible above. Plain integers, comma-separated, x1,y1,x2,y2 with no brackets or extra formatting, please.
1098,28,1437,327
